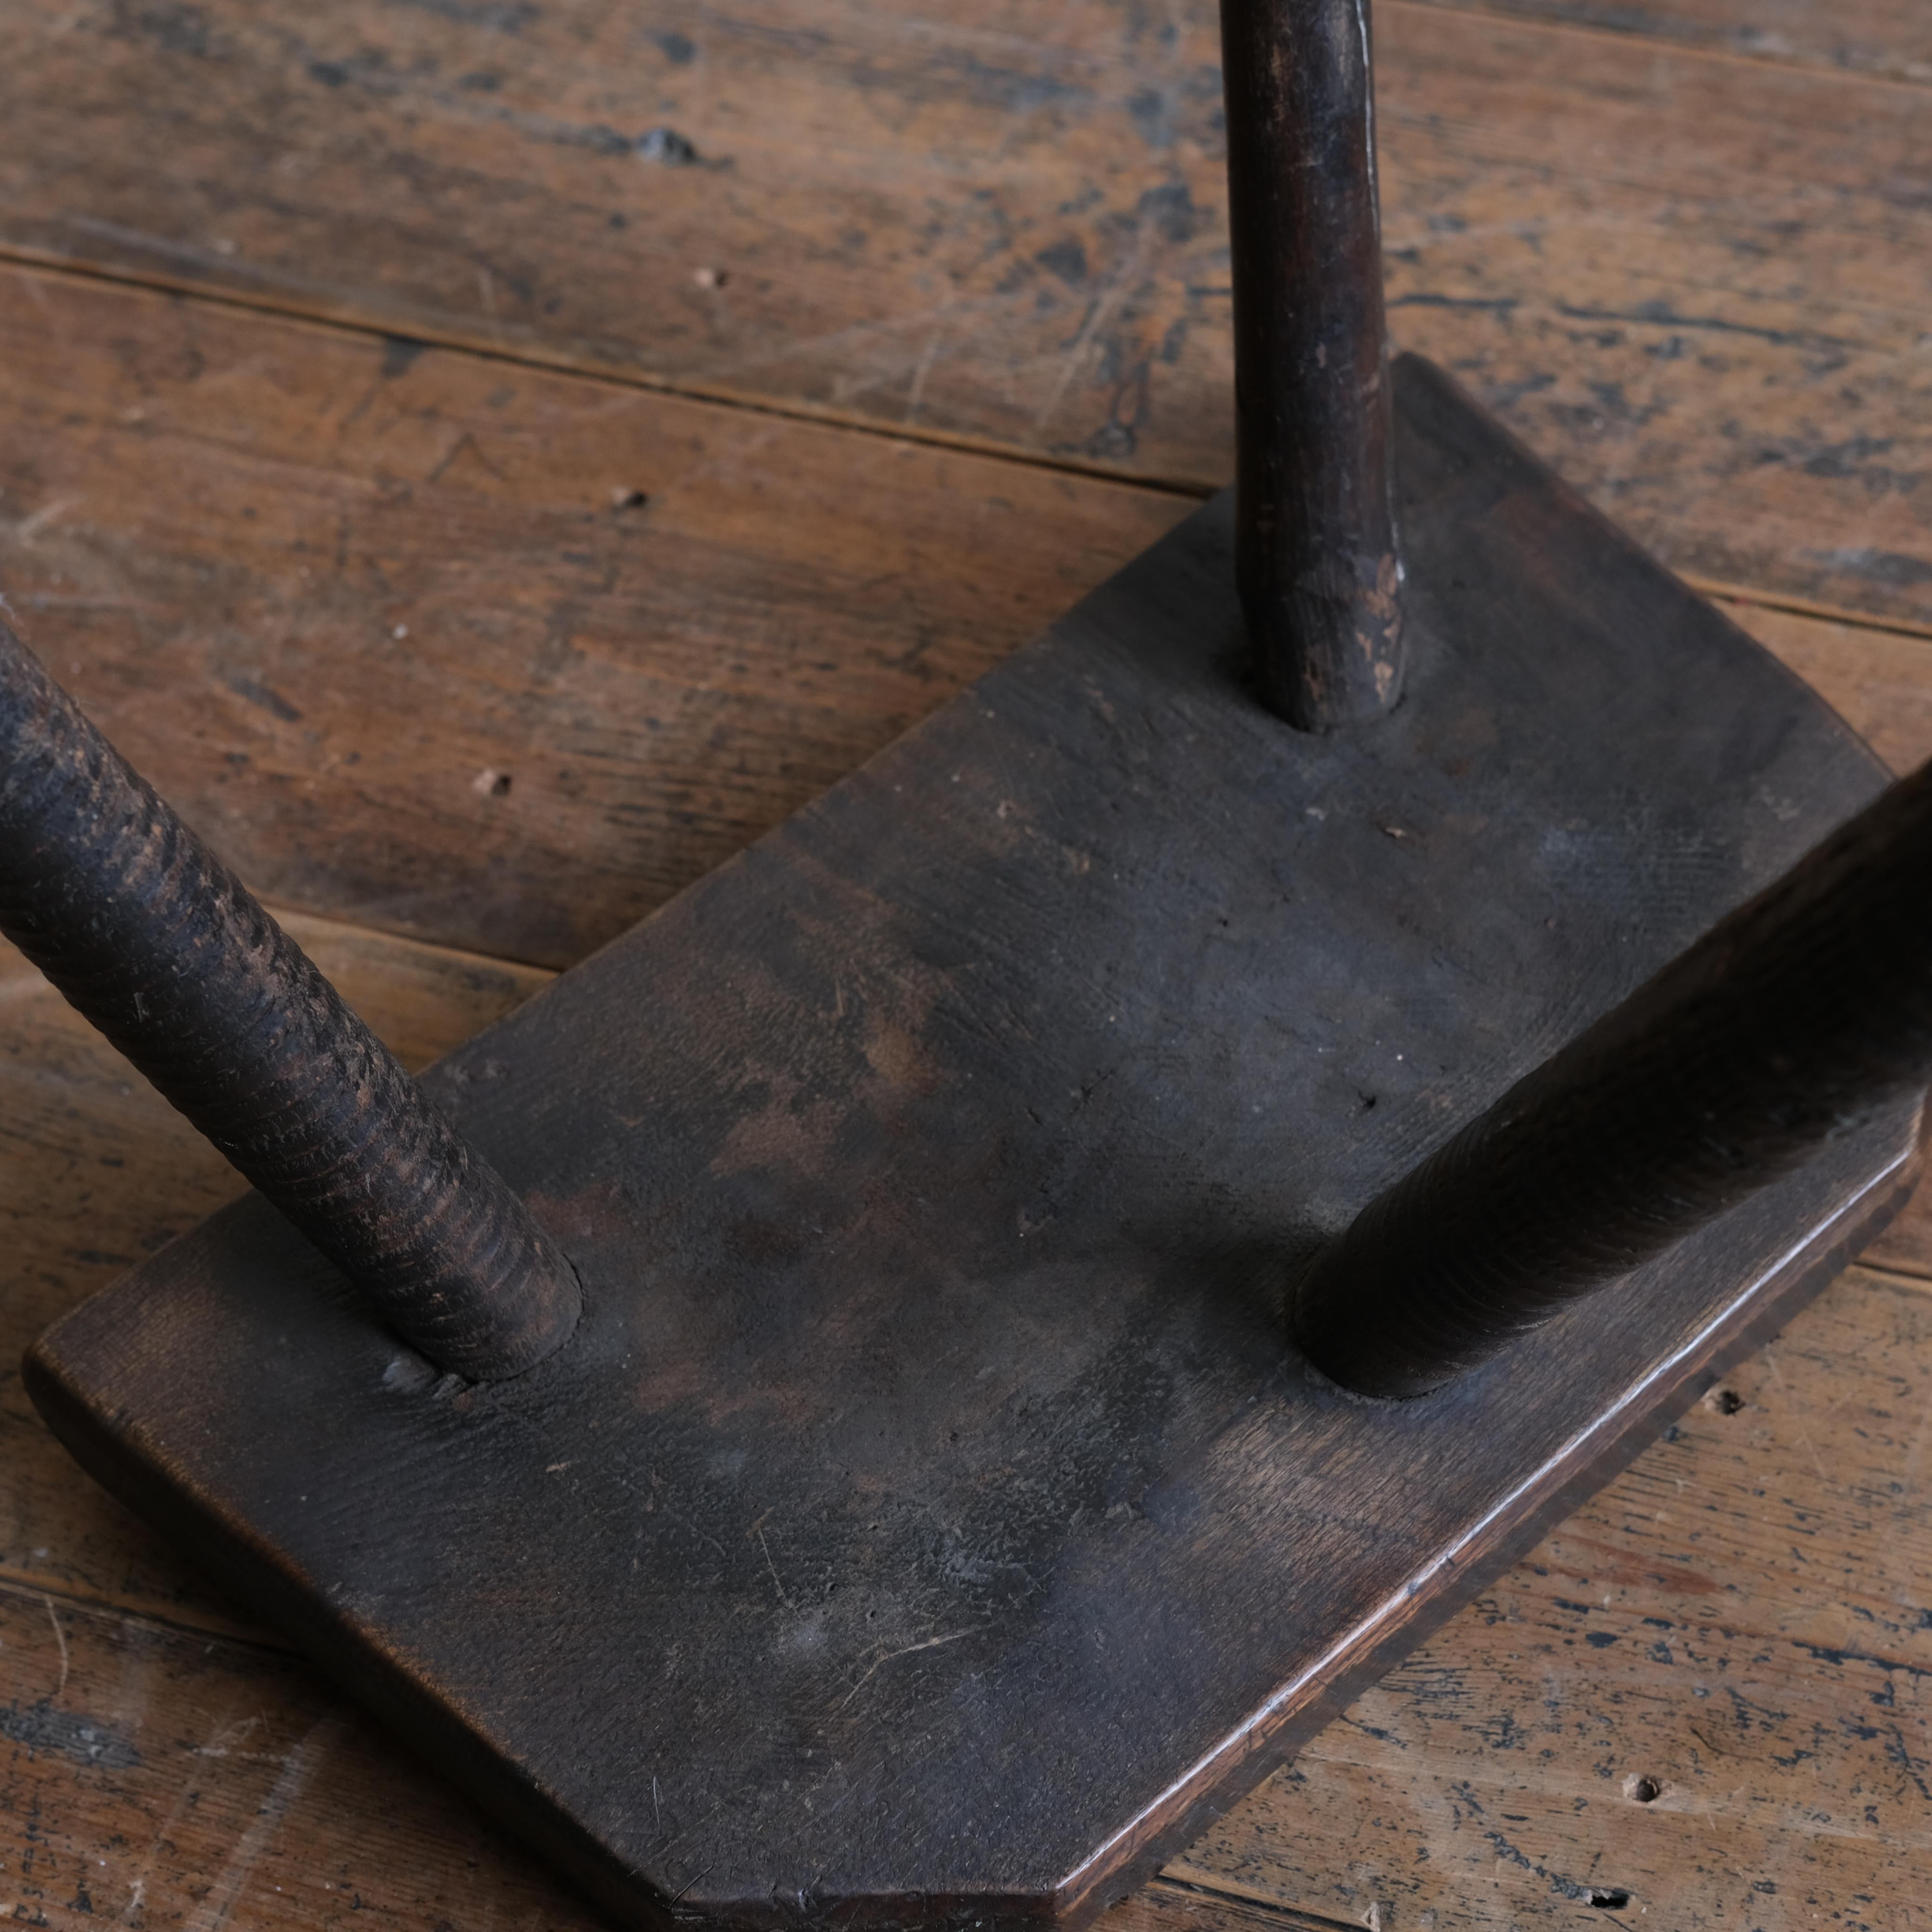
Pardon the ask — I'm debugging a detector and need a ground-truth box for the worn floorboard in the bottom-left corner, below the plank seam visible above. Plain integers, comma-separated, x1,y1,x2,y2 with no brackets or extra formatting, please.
0,1582,597,1932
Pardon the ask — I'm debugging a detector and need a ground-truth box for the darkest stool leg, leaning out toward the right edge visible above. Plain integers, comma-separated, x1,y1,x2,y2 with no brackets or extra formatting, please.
1294,745,1932,1397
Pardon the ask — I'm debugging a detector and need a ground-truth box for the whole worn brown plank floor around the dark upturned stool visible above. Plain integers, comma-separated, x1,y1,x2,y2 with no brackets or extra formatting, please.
0,0,1932,1932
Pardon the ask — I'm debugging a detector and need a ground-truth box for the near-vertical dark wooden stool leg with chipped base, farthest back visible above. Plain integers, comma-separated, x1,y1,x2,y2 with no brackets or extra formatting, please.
1221,0,1403,730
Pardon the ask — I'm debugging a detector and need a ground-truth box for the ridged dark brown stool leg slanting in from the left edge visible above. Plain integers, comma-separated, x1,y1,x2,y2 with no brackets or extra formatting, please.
0,626,578,1379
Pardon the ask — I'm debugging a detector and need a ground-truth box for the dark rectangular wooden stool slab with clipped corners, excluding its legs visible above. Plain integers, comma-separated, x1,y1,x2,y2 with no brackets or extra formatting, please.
29,361,1917,1926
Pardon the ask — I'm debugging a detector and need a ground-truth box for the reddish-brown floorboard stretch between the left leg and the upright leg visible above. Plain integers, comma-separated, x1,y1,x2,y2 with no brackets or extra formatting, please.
0,259,1190,964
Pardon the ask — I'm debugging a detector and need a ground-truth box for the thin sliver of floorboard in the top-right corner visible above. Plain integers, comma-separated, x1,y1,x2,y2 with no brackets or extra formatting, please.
1434,0,1932,83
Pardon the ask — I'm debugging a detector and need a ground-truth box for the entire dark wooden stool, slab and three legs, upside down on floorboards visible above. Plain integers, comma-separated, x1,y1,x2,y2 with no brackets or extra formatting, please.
0,0,1932,1926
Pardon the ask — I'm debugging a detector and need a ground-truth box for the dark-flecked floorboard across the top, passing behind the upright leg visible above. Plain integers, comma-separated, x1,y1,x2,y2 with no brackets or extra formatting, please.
0,0,1932,622
